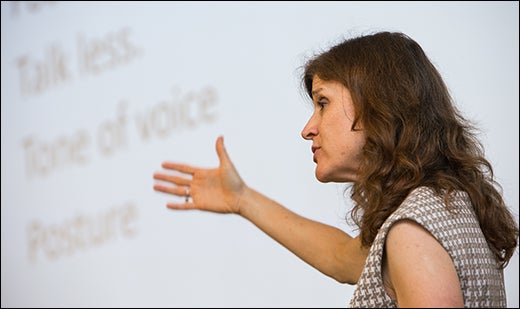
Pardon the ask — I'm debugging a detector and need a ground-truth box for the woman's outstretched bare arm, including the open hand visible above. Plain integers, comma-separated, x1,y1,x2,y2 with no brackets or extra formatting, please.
154,137,368,284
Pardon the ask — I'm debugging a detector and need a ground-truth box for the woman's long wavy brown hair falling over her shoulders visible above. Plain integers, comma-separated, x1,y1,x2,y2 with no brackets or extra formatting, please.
302,32,518,267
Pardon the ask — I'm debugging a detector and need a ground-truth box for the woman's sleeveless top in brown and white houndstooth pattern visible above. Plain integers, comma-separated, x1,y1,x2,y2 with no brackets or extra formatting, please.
349,187,506,308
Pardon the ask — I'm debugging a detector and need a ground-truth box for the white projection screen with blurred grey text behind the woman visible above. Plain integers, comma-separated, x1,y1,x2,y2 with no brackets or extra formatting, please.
1,1,519,307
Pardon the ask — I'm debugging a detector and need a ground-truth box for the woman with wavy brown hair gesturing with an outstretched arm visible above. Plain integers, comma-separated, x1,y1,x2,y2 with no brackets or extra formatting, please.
154,32,518,307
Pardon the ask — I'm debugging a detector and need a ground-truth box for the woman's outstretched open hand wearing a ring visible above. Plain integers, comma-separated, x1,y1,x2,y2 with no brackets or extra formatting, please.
153,136,246,213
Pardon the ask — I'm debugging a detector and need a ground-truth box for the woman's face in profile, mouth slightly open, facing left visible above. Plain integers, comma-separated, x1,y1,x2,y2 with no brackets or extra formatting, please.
302,75,365,182
